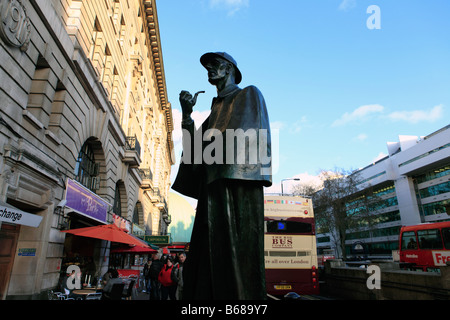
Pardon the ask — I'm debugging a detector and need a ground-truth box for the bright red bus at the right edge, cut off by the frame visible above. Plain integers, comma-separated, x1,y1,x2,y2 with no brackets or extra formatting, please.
399,221,450,271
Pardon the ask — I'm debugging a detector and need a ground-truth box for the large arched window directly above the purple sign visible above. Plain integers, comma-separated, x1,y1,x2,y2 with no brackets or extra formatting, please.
75,141,100,192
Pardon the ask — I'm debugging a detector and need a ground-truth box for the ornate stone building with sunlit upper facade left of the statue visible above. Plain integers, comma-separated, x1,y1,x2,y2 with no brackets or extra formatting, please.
0,0,174,299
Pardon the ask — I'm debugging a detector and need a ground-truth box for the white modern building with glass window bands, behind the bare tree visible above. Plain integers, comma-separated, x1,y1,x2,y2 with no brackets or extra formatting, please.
317,125,450,257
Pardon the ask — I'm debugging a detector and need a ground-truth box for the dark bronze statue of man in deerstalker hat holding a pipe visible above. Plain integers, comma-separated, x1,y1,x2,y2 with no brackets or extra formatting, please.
173,52,272,300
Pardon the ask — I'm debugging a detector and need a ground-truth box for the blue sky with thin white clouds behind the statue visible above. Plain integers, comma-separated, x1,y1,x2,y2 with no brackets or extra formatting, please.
157,0,450,200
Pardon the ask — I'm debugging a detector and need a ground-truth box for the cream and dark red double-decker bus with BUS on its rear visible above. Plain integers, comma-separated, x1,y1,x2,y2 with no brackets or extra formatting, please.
264,196,319,296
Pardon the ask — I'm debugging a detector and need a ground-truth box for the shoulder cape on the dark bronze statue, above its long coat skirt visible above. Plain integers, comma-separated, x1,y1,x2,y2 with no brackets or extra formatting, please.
172,86,272,199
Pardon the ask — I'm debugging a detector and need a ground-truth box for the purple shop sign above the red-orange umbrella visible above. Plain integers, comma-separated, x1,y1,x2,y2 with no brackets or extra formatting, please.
66,179,108,222
